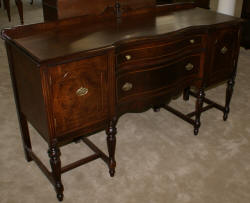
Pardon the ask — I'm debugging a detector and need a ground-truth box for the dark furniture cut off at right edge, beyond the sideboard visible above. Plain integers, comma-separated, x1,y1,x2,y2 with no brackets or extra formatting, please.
241,0,250,49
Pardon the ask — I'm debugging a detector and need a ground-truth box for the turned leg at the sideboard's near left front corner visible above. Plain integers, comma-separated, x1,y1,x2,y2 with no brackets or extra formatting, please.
48,140,64,201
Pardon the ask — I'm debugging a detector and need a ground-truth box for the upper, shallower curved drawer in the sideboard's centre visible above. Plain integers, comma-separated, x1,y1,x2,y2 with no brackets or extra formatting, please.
117,35,202,65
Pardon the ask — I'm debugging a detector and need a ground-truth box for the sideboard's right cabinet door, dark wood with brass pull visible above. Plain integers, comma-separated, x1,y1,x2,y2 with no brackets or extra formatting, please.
209,29,238,84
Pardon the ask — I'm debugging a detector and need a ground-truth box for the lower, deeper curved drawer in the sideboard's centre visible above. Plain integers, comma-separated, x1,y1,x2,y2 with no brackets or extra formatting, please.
116,54,200,102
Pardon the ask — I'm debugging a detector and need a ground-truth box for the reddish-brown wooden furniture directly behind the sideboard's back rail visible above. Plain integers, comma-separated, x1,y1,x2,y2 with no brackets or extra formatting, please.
43,0,155,21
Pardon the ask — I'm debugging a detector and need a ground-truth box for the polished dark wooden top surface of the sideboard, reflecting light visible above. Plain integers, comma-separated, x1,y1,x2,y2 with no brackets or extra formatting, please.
2,8,241,62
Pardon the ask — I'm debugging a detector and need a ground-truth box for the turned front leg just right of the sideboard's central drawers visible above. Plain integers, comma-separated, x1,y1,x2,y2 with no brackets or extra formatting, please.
194,88,205,135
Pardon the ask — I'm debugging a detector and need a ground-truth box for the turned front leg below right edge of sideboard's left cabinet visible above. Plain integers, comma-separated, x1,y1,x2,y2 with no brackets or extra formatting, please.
106,119,117,177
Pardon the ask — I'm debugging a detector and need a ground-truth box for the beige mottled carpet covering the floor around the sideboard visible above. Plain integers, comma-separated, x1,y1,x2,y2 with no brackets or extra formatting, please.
0,2,250,203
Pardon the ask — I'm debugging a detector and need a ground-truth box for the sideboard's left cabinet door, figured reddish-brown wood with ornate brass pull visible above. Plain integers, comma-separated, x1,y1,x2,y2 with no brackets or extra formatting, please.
50,56,108,135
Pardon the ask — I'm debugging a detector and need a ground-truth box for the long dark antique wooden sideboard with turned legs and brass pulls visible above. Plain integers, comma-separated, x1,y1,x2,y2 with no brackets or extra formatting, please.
1,0,242,200
